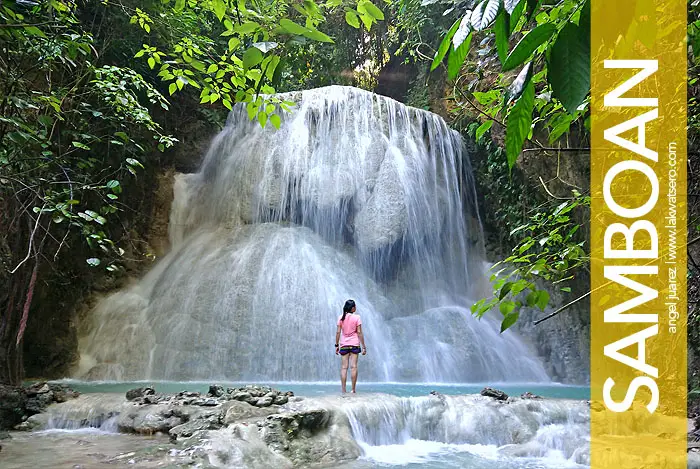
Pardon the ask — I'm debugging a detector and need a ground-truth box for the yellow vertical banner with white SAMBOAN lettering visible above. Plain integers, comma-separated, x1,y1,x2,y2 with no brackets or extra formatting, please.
591,0,687,469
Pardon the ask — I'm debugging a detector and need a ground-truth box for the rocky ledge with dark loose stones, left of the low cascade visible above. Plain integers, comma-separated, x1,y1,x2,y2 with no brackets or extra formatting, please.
15,385,361,468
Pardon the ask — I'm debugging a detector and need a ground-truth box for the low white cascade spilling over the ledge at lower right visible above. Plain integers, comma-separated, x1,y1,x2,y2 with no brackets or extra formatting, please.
342,395,590,467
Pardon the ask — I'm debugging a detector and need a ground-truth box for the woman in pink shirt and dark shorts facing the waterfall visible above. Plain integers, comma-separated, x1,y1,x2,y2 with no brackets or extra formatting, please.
335,300,367,394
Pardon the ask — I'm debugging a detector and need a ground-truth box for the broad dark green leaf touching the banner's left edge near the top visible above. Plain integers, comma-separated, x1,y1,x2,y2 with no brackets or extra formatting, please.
547,23,591,113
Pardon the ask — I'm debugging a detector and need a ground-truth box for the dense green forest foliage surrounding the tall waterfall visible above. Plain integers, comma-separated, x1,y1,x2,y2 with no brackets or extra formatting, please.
0,0,700,389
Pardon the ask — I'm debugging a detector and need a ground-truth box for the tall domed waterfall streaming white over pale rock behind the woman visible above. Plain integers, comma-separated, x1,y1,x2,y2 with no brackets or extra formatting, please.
78,86,548,382
